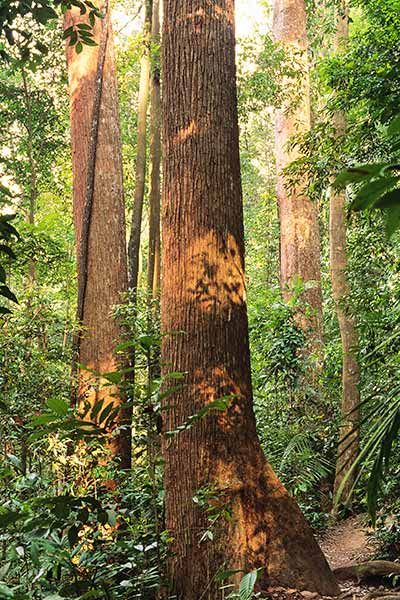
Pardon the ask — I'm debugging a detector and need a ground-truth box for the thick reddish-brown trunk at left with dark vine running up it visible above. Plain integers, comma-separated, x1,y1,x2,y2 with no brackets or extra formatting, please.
64,3,131,467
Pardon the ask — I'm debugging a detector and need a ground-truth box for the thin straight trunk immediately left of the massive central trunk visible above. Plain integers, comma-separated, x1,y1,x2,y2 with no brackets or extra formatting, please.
147,0,161,300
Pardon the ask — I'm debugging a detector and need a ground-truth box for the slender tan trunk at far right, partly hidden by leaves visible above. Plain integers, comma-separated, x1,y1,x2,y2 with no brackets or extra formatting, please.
329,1,360,506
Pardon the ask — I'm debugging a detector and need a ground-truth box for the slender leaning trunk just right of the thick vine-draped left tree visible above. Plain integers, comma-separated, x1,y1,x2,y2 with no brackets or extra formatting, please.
128,0,153,290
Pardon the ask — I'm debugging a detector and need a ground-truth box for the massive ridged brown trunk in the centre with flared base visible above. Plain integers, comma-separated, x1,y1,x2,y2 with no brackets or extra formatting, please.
162,0,338,600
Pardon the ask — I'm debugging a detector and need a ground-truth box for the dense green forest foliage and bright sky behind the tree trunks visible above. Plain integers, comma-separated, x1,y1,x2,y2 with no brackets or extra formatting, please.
0,0,400,600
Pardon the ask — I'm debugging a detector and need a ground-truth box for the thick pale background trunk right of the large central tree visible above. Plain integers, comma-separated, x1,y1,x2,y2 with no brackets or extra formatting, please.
273,0,323,357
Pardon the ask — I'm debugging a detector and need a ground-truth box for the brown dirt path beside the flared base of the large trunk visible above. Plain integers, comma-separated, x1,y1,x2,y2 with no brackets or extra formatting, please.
320,515,377,569
